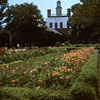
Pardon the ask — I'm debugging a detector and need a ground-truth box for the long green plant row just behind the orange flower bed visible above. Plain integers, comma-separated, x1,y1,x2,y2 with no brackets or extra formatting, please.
0,47,66,64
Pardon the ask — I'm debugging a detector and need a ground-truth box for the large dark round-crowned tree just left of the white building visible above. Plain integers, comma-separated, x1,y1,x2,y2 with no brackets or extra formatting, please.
5,3,43,44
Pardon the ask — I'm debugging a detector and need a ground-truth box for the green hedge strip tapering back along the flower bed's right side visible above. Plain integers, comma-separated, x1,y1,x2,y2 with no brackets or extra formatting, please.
70,50,98,100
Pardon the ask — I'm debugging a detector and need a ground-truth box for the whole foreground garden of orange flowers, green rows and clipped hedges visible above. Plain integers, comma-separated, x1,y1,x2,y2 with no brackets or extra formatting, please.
0,46,100,100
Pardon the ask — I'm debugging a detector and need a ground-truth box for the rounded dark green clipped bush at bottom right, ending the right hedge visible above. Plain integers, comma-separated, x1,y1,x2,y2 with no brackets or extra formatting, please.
70,82,97,100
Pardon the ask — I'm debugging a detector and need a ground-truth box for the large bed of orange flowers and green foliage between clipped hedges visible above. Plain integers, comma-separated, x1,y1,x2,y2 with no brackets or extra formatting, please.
0,47,94,88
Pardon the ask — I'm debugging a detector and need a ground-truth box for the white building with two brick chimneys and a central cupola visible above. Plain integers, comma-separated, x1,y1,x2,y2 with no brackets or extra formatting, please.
45,0,70,30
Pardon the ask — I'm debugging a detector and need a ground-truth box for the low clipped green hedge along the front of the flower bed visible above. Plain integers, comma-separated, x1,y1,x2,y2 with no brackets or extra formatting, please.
0,87,72,100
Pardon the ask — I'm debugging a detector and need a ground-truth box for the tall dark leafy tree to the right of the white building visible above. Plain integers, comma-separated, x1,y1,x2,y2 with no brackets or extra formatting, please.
71,0,100,43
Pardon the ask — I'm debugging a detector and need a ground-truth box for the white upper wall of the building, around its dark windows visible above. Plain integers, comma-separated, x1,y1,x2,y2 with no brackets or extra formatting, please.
45,16,68,28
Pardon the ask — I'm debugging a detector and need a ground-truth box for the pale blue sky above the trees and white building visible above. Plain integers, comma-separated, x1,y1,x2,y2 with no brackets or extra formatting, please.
8,0,80,19
